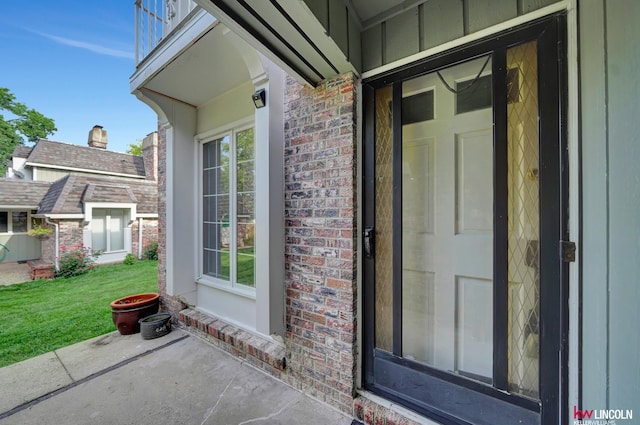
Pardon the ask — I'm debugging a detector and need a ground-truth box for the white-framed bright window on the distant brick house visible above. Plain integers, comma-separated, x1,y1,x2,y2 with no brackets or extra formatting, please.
91,208,127,252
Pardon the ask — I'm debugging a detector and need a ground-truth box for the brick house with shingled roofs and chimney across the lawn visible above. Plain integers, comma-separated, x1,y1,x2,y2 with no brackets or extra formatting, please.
0,126,158,264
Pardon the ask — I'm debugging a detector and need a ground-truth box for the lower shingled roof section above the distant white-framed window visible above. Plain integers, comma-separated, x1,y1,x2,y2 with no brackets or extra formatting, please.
37,173,158,214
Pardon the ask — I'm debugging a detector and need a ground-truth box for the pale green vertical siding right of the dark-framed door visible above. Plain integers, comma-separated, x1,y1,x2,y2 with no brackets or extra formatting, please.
579,0,640,412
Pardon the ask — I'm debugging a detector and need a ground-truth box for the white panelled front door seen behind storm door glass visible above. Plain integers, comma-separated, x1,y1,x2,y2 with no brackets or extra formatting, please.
402,58,493,380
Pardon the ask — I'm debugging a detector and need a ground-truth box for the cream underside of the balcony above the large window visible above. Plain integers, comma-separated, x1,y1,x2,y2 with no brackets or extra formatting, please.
145,25,250,107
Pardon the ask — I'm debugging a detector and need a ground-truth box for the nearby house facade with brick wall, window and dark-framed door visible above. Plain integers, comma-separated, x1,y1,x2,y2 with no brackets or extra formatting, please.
130,0,640,425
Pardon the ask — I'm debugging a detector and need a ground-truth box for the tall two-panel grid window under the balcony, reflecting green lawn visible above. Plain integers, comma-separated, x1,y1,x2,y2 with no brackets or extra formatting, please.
201,128,256,288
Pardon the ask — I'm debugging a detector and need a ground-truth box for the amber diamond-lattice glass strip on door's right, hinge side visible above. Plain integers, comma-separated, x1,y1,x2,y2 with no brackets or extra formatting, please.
507,42,540,399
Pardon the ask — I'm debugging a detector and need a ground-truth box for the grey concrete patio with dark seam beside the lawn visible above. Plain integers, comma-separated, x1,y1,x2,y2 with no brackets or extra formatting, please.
0,329,352,425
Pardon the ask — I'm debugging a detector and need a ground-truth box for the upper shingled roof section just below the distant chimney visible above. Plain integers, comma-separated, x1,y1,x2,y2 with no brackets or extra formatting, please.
25,139,145,178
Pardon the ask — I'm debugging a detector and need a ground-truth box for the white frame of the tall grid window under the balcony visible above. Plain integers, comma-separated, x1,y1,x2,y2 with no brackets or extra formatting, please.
195,117,261,299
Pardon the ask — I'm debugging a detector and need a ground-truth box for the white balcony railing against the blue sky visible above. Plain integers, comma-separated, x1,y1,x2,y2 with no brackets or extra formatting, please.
135,0,197,66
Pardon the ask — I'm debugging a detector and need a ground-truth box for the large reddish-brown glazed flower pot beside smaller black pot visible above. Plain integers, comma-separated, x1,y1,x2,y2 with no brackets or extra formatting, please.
111,292,160,335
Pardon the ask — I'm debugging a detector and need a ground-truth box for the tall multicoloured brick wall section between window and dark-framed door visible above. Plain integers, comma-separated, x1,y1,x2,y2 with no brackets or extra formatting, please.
283,74,357,413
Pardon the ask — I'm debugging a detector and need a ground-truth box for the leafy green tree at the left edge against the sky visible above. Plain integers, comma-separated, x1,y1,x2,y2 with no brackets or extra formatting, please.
0,87,57,176
